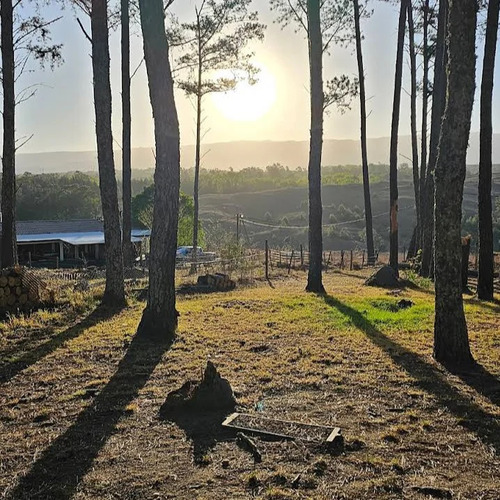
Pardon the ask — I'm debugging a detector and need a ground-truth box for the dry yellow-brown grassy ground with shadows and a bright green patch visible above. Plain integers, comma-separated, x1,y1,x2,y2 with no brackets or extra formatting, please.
0,272,500,500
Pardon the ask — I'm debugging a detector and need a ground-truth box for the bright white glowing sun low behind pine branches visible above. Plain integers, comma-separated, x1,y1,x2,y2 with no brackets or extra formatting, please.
212,64,277,122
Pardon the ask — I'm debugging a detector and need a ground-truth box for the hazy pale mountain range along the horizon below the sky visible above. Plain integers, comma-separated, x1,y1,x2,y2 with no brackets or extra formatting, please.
16,133,500,173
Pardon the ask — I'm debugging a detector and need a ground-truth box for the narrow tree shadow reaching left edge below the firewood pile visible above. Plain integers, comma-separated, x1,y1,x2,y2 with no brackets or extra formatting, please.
0,306,122,384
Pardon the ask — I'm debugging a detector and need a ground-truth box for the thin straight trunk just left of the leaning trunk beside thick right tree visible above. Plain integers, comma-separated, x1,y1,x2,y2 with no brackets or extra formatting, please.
417,0,429,249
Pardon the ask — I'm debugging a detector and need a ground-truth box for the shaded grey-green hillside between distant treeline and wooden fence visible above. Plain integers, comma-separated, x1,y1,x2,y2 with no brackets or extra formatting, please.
200,173,500,250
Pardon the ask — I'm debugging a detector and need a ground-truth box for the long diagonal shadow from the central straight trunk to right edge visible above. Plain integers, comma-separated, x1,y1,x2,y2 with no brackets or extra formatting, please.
320,295,500,455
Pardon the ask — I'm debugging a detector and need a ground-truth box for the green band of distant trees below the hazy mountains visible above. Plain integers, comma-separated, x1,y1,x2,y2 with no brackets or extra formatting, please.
8,165,500,245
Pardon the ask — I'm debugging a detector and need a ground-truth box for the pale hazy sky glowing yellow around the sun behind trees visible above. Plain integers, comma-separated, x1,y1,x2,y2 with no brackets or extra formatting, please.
13,0,500,152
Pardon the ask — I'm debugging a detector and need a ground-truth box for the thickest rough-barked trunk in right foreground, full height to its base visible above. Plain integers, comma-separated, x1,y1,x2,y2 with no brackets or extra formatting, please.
434,0,477,368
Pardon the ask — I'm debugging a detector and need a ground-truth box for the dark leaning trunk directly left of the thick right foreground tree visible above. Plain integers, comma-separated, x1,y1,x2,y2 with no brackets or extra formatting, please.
420,0,448,277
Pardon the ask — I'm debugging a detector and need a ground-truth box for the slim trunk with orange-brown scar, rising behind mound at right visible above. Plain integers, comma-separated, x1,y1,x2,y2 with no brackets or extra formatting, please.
389,0,408,273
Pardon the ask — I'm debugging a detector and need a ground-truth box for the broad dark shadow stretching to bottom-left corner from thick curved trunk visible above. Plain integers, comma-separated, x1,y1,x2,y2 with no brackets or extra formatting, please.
8,328,171,500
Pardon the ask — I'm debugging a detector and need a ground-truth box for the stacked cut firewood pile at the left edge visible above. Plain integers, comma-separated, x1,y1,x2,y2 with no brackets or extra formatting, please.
0,266,53,313
